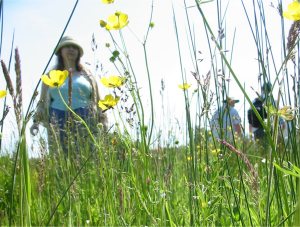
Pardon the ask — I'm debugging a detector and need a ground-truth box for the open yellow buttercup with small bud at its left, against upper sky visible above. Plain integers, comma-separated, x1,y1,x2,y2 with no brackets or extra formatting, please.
100,11,129,30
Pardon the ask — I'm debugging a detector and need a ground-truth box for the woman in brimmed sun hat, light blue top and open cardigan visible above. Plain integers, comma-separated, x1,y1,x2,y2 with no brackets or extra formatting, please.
30,36,107,153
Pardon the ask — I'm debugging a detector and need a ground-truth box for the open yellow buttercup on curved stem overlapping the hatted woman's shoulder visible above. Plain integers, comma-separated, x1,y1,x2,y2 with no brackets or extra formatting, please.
41,70,69,87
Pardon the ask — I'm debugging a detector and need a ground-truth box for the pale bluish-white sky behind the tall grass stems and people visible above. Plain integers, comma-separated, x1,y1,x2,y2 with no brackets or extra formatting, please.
0,0,291,154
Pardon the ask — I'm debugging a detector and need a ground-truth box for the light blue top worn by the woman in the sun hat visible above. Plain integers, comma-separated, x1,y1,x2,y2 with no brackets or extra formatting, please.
49,72,92,111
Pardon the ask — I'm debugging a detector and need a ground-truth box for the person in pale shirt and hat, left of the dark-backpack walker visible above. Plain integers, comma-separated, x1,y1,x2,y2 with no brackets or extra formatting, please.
210,97,242,142
